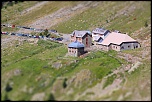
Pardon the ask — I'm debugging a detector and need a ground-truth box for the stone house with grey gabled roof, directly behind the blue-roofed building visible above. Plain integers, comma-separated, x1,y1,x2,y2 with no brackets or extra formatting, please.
71,30,92,47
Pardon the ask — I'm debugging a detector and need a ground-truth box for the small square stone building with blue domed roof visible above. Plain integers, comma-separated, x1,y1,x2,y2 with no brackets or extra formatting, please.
68,41,85,57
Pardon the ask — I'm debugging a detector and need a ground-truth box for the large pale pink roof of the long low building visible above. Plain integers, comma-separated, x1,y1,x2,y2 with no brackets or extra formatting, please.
98,32,136,45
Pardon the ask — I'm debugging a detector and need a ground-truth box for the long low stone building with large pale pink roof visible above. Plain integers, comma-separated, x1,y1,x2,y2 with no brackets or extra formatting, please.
98,32,140,51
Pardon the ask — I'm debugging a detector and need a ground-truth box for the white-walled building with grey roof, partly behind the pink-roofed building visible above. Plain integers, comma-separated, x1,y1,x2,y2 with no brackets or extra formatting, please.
92,28,110,42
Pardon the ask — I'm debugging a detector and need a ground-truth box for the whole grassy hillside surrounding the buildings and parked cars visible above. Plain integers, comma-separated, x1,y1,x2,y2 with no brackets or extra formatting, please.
1,1,151,101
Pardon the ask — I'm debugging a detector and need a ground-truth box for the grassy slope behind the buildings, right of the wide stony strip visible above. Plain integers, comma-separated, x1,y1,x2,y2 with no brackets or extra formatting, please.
51,1,151,33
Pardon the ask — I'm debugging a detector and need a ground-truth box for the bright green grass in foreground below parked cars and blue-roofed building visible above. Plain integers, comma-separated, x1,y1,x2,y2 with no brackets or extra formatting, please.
2,40,120,100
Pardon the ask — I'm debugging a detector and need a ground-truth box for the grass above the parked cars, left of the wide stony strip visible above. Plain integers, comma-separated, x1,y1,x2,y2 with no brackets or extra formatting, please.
2,1,81,25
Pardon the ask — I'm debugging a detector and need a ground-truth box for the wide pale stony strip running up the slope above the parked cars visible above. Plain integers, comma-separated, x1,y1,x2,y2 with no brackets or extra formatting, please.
18,1,99,33
